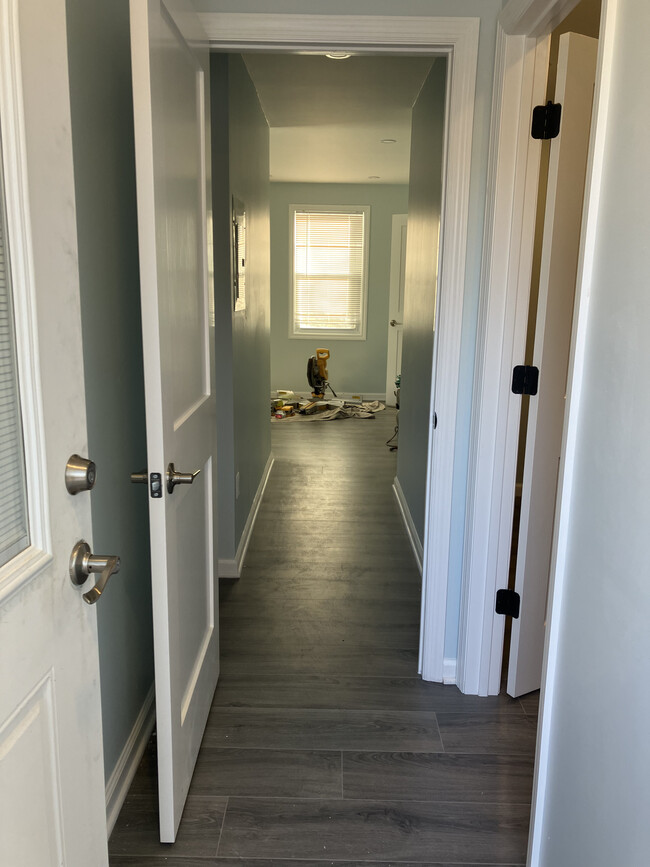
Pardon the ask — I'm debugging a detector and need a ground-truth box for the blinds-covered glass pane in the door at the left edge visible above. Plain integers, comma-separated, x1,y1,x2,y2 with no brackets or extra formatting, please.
0,138,29,566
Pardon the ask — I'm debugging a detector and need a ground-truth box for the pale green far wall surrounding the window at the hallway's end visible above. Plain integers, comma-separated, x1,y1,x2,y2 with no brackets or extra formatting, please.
271,183,408,394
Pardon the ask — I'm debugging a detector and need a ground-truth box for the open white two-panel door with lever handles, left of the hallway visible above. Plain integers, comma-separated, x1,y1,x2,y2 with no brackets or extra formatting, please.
131,0,219,842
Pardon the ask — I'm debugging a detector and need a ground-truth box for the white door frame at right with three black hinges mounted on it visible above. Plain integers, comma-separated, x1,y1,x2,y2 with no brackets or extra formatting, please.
458,0,616,695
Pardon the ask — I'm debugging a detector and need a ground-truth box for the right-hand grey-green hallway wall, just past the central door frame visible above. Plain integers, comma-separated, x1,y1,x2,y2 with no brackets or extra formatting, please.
397,59,447,542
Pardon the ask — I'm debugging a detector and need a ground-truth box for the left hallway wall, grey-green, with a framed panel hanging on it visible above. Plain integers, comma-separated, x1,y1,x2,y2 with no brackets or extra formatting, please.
211,54,271,560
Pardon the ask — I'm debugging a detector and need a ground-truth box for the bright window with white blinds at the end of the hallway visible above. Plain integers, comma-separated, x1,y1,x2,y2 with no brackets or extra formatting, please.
289,205,370,340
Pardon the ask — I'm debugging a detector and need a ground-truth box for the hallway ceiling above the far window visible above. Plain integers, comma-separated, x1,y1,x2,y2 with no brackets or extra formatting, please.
239,54,436,184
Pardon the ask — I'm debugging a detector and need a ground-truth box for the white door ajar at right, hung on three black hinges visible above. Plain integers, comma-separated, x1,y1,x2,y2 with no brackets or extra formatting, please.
507,33,598,696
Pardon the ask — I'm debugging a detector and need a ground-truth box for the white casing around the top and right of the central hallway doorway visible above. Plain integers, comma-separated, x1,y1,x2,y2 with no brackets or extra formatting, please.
200,13,480,681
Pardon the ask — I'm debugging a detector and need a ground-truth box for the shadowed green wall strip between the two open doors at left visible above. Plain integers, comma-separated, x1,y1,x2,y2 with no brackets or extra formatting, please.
67,0,153,779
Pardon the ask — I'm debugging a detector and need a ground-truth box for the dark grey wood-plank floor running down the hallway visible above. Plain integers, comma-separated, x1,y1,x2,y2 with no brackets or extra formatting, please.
110,411,537,867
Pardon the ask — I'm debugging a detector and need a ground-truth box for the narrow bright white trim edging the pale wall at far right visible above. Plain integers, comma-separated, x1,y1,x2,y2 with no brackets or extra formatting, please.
527,0,618,867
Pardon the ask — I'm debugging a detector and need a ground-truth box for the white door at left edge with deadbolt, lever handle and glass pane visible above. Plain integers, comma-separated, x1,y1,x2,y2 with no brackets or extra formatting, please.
0,0,107,867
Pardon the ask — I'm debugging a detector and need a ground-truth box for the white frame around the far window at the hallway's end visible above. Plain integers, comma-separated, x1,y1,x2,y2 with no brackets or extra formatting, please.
289,204,370,340
